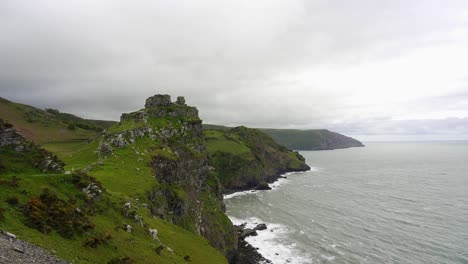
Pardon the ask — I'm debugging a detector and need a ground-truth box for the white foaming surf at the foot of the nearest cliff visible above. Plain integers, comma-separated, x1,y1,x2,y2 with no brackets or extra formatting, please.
229,216,312,264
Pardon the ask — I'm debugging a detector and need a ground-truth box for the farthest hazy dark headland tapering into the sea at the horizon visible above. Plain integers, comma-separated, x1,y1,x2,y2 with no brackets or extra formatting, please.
261,129,364,150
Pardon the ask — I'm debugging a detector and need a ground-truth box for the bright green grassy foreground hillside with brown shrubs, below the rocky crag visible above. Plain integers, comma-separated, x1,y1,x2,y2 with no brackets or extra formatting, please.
0,97,232,263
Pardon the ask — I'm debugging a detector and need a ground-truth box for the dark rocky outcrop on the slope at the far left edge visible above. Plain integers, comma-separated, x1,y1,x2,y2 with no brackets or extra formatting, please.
0,119,65,172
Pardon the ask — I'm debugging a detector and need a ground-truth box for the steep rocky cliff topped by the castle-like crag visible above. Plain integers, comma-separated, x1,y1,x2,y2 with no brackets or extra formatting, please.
106,95,237,262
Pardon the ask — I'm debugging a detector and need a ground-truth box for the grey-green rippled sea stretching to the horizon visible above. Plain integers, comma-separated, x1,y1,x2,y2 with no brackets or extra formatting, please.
225,142,468,264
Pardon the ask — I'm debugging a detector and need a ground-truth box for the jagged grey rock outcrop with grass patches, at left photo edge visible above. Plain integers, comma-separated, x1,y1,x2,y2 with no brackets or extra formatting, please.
0,119,64,172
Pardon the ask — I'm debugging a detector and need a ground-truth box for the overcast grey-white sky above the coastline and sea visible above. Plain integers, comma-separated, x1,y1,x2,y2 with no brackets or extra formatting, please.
0,0,468,140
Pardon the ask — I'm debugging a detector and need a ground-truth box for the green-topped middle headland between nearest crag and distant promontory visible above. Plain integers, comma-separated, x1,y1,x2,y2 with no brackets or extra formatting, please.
205,127,310,192
